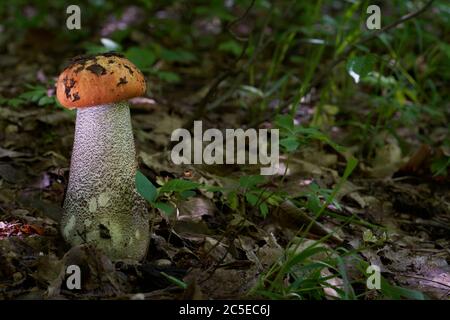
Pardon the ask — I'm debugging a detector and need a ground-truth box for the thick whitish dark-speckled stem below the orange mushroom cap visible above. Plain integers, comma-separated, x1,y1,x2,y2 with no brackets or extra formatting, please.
61,102,149,260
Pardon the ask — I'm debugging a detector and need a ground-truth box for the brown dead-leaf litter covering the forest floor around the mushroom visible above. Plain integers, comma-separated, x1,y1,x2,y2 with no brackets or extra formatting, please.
0,1,450,299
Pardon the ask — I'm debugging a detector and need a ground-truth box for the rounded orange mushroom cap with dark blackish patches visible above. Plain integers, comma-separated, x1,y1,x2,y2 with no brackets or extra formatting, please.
56,53,146,109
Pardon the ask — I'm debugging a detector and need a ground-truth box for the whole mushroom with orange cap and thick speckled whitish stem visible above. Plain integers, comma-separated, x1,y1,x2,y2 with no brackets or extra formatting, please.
56,53,150,260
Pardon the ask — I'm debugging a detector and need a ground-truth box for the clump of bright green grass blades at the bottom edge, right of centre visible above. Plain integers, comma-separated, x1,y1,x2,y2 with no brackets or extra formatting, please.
250,238,426,300
